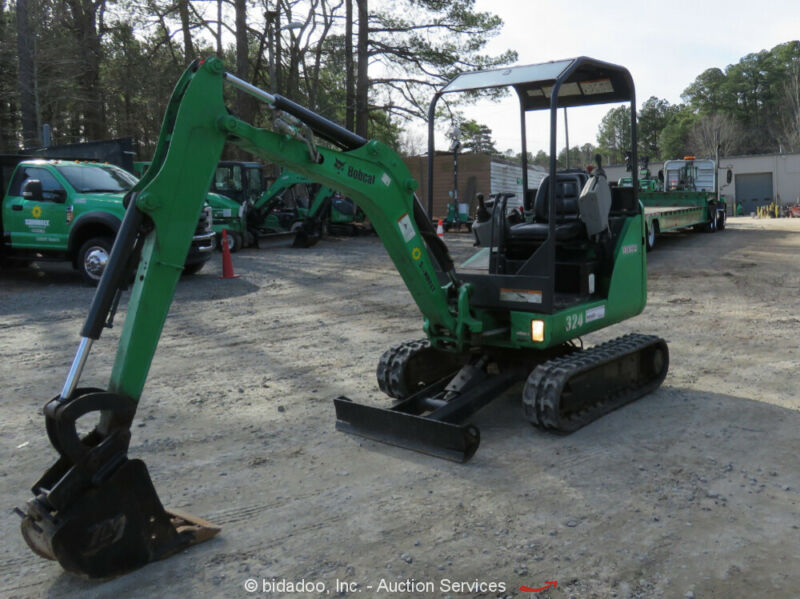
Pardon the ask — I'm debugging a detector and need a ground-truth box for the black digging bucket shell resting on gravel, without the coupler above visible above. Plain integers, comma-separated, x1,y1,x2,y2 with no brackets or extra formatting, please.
22,460,220,579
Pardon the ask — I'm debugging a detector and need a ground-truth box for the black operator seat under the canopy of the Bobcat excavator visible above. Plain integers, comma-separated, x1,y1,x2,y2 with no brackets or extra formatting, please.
506,173,586,244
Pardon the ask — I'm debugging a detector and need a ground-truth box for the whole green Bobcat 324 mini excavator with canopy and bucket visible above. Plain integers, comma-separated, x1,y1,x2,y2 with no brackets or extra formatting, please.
18,57,669,578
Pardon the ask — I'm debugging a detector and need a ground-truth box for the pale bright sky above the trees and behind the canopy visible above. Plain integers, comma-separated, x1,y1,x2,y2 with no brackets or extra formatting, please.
460,0,800,154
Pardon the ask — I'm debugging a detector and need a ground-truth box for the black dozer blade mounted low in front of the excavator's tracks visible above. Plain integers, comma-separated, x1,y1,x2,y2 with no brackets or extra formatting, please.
333,397,481,462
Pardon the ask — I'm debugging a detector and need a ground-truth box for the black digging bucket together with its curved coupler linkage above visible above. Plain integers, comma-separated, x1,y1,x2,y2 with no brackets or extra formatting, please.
17,390,220,579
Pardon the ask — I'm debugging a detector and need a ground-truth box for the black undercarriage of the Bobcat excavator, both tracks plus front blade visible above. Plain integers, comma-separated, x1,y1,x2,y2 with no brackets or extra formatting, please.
334,334,669,462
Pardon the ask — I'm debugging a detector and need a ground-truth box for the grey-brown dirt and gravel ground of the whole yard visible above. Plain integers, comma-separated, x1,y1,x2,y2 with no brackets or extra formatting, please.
0,218,800,599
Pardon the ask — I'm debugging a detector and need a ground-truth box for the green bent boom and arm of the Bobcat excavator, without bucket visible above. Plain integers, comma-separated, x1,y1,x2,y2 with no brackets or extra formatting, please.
110,59,480,399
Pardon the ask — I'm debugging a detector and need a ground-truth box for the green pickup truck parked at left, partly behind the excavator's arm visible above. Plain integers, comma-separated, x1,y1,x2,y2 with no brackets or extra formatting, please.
0,156,215,285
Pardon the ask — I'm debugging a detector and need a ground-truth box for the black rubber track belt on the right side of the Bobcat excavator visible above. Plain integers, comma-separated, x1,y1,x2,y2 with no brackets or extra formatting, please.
522,334,669,433
